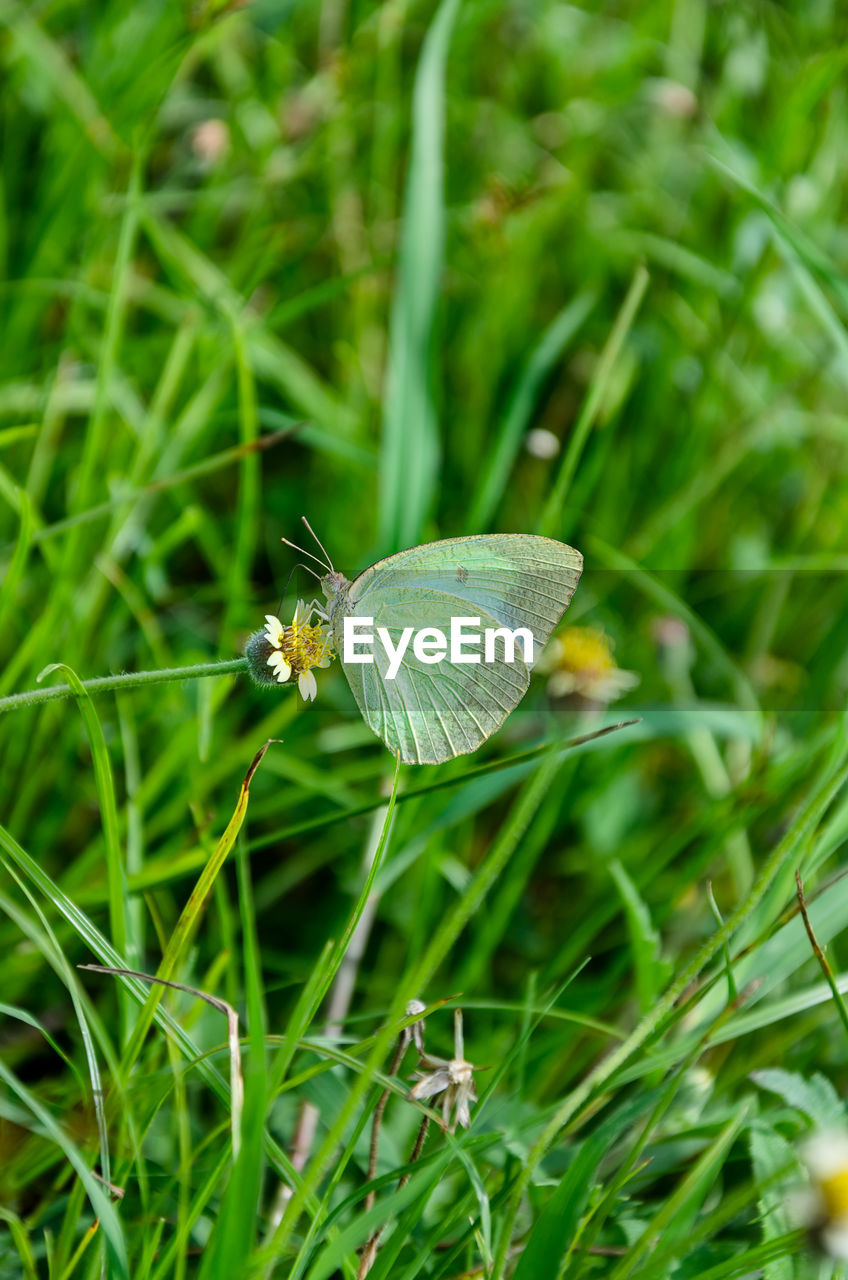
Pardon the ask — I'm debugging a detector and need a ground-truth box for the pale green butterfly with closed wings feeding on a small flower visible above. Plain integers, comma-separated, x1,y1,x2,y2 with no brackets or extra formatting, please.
289,521,583,764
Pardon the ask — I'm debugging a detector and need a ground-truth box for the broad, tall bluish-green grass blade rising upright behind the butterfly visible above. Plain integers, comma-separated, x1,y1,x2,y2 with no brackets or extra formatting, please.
378,0,459,550
